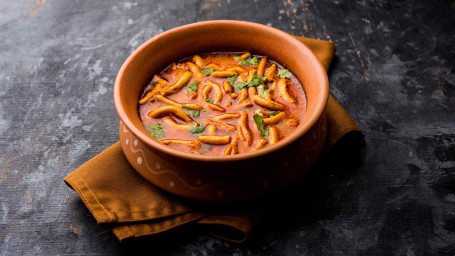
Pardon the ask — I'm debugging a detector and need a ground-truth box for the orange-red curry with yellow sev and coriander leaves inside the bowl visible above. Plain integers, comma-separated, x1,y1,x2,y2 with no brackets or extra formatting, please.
139,52,306,155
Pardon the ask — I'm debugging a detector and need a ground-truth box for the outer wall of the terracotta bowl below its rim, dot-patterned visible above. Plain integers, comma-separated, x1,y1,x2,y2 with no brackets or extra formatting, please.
119,115,327,201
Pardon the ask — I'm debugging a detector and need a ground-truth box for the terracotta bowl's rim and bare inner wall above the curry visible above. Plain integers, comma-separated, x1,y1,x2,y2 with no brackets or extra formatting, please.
114,21,328,161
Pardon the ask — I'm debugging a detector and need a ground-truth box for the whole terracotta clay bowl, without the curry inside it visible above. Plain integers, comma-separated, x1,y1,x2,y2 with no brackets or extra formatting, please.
114,20,329,201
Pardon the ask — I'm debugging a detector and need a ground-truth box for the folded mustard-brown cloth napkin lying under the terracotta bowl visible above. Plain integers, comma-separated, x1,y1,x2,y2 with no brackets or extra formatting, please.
64,37,363,242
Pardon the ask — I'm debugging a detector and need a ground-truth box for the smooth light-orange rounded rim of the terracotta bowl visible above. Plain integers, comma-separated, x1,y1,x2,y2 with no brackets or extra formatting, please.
114,20,329,162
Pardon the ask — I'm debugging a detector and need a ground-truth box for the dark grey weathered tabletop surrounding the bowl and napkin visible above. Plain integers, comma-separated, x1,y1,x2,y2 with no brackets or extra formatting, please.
0,0,455,255
